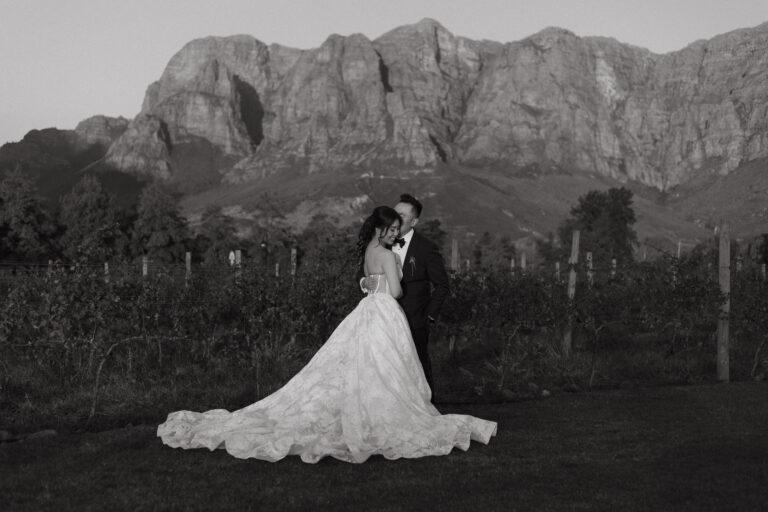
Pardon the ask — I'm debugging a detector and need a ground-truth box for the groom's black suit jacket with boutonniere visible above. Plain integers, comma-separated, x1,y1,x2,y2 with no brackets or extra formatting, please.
358,230,450,330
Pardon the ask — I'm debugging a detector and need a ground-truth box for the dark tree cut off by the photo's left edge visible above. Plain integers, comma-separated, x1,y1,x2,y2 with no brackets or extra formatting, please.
0,168,56,261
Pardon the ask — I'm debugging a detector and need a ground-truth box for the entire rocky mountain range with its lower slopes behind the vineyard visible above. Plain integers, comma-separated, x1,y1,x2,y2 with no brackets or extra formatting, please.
0,19,768,252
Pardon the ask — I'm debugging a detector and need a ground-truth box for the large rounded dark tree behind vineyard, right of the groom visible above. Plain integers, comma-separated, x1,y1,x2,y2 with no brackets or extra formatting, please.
558,187,637,264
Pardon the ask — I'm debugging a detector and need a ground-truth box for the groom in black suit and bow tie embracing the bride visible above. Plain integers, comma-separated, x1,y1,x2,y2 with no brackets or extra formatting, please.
366,194,450,394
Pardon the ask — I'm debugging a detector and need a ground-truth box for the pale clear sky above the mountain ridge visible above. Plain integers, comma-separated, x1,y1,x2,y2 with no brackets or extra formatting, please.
0,0,768,144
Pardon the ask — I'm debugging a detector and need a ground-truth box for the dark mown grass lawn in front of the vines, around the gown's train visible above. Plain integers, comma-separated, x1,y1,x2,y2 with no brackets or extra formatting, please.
0,383,768,511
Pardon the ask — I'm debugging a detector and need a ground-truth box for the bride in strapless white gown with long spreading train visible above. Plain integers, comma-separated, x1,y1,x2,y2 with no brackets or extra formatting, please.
157,206,496,463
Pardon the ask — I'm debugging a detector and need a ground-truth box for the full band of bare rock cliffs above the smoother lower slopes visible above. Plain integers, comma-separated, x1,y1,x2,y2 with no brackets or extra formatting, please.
107,19,768,190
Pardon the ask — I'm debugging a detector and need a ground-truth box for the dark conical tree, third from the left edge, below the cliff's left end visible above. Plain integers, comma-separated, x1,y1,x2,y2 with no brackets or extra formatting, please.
132,182,189,262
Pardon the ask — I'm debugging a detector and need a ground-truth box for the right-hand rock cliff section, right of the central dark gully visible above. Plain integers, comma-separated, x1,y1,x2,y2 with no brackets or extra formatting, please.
457,25,768,190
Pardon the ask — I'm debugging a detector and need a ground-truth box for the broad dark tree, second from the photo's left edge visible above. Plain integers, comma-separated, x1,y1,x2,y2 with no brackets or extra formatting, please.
59,176,128,262
